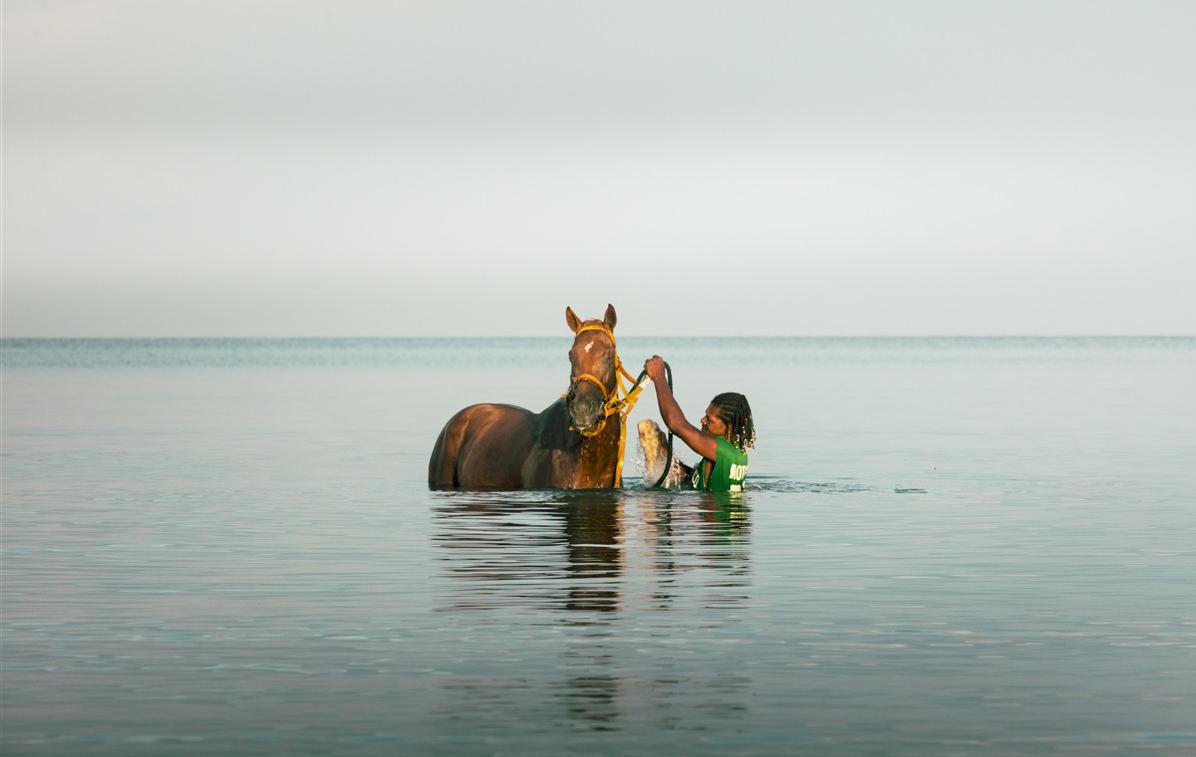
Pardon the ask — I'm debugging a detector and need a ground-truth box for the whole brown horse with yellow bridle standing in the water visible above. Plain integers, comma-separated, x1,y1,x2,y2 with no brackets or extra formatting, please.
428,305,622,489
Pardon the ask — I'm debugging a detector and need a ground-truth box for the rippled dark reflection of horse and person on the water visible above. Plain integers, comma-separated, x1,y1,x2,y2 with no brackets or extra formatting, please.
433,490,751,731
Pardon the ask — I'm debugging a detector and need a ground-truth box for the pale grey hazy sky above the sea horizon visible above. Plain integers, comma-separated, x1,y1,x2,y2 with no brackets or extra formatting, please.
0,0,1196,337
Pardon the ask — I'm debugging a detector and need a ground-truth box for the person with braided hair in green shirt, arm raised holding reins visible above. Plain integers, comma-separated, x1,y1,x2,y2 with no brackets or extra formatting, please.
643,355,756,492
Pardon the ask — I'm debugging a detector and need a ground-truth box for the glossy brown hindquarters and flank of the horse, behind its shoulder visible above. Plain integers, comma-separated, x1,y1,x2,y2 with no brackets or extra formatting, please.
428,403,536,489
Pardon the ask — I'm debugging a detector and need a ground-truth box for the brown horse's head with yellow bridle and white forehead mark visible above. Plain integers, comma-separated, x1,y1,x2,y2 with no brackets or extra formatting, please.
565,305,616,434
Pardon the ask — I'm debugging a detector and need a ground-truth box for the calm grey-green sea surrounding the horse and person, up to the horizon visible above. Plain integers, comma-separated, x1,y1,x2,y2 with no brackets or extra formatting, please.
0,337,1196,756
